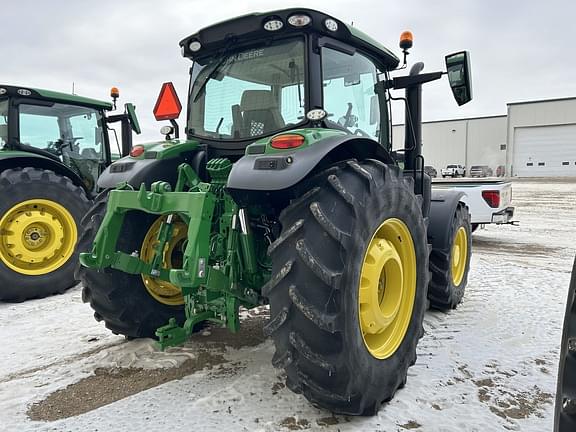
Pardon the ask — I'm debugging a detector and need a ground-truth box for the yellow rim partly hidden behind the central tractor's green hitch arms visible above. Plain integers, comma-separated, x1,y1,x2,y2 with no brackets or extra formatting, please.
140,216,188,306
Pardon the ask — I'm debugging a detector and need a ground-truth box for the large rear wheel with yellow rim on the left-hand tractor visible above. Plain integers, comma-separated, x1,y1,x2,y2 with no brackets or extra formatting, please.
0,167,90,302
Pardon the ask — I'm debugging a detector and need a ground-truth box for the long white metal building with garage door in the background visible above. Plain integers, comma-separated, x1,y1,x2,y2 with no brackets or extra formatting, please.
393,97,576,177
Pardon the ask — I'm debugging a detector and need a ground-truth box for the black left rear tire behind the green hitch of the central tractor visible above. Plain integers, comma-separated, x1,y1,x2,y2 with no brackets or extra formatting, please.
78,192,185,338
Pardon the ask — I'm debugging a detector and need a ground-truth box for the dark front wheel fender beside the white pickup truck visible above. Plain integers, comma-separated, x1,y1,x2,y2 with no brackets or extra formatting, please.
428,189,467,250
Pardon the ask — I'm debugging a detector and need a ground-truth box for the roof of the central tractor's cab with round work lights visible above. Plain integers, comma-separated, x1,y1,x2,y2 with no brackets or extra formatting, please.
180,8,400,68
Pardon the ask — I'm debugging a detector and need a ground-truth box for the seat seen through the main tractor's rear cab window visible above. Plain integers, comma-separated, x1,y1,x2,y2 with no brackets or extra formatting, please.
235,90,285,137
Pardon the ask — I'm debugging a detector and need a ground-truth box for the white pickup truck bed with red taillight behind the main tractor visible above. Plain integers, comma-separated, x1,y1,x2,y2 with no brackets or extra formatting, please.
432,178,515,231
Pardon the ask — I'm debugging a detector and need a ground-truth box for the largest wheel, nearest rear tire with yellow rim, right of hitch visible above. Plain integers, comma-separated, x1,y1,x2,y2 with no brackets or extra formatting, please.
263,161,428,415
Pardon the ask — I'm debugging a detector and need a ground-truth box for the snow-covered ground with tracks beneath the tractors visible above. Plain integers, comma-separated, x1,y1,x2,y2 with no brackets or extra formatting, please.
0,182,576,432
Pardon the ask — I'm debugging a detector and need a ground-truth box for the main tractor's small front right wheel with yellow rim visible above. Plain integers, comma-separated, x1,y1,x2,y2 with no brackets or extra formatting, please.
428,203,472,310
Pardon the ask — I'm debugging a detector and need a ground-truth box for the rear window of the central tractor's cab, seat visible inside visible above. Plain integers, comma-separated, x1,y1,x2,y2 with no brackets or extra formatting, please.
188,38,305,140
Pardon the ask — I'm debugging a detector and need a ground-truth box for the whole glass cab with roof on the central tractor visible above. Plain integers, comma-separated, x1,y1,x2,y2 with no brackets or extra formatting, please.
181,9,399,154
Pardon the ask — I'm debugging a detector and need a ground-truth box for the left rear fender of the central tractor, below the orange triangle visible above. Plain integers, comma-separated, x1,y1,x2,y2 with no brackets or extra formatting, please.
98,151,206,189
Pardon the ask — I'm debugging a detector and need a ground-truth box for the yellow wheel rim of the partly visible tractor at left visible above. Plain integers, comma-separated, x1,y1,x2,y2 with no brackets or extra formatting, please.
0,199,78,276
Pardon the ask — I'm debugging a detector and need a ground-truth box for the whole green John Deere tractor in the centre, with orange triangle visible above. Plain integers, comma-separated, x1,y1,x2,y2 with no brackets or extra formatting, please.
80,9,471,415
